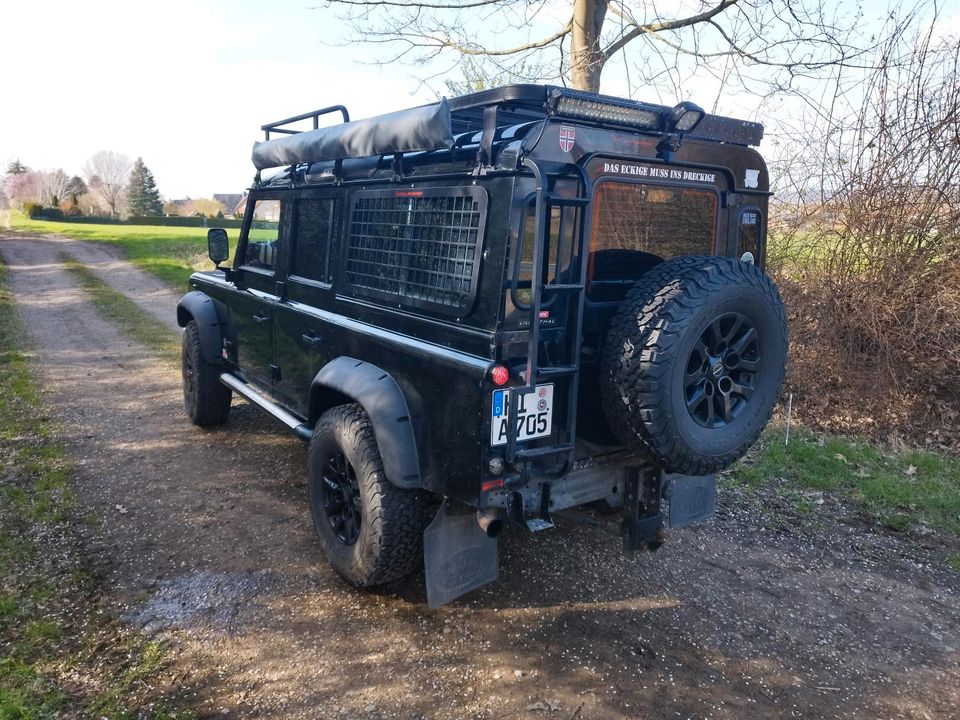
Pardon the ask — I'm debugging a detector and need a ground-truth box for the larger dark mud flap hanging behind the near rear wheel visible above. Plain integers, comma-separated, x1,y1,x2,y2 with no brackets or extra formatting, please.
423,499,500,608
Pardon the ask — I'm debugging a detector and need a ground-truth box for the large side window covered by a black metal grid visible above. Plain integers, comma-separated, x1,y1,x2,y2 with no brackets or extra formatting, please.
344,187,487,315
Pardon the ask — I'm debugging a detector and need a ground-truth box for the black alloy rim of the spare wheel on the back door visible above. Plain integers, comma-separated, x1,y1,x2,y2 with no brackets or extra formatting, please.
684,313,761,428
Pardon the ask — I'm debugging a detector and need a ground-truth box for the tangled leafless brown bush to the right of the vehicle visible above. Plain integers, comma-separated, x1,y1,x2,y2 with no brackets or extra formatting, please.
768,32,960,447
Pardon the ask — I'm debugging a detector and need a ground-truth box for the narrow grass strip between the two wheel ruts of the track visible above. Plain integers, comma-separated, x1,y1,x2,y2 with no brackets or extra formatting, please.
63,258,180,365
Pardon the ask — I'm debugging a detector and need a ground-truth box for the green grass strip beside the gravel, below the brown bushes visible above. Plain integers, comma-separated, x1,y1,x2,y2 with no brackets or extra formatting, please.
730,426,960,535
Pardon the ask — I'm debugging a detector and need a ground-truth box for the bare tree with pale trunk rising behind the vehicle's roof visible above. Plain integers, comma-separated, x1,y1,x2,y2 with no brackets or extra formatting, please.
326,0,900,91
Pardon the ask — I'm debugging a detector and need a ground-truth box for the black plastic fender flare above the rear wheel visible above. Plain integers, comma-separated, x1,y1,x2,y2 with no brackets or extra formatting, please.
308,356,423,490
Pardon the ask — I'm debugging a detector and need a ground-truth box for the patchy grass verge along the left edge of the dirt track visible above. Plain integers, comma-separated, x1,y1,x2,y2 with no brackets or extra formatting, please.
0,264,193,720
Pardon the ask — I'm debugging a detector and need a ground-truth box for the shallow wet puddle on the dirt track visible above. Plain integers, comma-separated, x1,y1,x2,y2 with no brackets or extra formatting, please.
128,571,280,635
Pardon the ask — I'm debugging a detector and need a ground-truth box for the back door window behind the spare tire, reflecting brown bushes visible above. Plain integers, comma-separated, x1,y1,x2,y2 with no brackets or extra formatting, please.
587,182,717,301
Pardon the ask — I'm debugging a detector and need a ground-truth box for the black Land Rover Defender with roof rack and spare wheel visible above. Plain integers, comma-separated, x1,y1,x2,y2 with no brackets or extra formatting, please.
177,85,787,605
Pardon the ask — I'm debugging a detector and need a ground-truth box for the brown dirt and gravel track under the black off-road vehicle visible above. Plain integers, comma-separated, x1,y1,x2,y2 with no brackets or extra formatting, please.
0,237,960,720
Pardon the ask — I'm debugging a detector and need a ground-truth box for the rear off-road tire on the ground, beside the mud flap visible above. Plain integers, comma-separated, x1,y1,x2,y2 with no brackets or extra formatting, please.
308,404,428,587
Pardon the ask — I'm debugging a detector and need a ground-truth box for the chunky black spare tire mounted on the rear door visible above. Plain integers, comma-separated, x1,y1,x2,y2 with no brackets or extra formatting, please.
600,256,788,475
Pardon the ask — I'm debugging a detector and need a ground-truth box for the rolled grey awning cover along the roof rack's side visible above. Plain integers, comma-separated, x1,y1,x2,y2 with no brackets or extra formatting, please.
253,98,453,170
